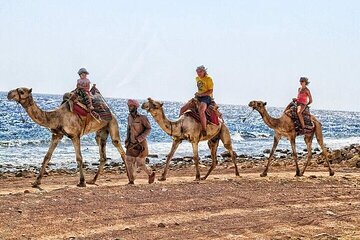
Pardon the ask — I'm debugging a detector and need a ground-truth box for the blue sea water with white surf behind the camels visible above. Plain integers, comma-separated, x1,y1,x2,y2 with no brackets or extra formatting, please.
0,92,360,172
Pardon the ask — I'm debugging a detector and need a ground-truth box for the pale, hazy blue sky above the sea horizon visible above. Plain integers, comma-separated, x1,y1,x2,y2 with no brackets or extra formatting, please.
0,0,360,111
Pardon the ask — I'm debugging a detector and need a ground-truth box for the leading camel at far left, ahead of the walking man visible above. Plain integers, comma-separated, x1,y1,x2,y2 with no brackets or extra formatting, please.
7,88,125,187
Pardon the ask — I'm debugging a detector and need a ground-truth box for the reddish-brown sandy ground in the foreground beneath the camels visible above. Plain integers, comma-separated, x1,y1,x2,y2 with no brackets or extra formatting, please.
0,166,360,239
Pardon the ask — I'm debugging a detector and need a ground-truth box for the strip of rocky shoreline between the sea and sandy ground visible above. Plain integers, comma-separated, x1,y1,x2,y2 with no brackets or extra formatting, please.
0,144,360,178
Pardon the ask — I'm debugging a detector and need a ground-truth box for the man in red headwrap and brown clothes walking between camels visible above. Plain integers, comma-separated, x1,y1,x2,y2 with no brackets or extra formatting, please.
125,99,155,184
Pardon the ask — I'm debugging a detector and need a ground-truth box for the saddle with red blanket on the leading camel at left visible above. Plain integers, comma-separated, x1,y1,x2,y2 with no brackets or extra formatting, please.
62,86,112,121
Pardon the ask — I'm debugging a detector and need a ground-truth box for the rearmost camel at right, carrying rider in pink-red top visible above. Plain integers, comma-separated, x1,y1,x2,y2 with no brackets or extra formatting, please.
249,101,334,177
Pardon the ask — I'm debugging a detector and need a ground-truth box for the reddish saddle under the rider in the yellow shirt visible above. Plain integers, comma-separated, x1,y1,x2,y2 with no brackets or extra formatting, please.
184,98,223,125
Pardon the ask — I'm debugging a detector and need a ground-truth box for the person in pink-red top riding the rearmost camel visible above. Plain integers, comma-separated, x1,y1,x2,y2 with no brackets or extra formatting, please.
293,77,312,129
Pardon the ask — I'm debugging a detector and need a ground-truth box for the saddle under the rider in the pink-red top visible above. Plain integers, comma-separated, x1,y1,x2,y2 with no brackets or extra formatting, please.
285,102,315,136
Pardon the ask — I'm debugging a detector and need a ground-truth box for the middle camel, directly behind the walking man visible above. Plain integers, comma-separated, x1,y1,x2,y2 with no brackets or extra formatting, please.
141,98,239,181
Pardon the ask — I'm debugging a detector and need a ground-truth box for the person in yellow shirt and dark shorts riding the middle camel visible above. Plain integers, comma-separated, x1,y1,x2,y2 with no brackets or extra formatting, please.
180,65,214,136
